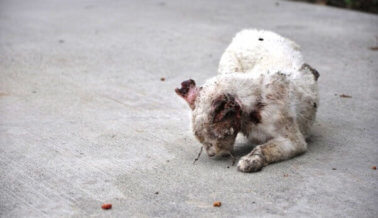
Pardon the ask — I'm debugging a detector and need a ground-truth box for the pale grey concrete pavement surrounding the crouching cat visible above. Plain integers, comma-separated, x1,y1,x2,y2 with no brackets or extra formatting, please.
0,0,378,217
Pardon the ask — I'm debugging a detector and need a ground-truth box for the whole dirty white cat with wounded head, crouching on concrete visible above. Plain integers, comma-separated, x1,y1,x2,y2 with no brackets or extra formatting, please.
176,30,319,172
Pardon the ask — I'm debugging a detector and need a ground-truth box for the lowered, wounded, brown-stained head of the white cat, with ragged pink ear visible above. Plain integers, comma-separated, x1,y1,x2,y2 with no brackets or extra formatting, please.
175,79,242,157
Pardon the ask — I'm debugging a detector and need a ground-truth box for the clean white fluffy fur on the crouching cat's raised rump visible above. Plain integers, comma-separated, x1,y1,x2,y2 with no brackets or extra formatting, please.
218,29,304,74
